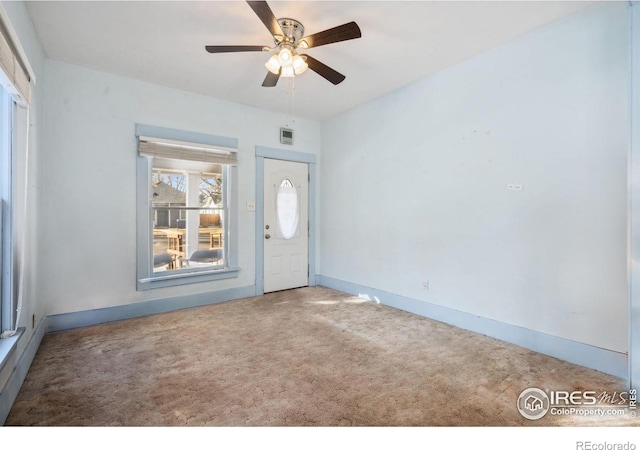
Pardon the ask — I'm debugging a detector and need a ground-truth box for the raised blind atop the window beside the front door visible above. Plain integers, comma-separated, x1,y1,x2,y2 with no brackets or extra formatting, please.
138,136,238,165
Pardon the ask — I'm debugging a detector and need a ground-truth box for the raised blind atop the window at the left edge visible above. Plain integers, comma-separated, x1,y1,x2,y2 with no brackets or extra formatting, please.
0,7,35,104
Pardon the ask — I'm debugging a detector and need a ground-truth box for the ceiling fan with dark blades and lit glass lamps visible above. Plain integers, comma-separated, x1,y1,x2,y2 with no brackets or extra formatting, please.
205,1,362,87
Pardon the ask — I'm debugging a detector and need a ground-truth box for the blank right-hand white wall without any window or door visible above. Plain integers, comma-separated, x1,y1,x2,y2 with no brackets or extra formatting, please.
318,2,629,352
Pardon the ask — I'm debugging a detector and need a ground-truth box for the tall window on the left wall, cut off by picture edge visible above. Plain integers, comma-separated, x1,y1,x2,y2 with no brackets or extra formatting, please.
0,3,36,342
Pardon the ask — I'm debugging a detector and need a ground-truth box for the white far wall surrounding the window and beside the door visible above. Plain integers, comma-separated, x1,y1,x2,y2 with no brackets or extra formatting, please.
38,60,320,314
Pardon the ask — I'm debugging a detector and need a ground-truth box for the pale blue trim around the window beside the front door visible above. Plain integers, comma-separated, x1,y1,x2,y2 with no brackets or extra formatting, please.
135,124,240,291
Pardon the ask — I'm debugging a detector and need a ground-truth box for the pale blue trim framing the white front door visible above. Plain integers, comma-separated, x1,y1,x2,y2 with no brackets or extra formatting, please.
255,146,316,295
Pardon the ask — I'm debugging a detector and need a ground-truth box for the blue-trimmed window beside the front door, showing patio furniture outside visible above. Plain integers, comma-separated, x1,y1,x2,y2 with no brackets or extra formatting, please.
137,125,238,289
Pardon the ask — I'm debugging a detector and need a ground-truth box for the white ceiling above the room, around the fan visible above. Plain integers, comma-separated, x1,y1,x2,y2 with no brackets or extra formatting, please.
27,0,593,120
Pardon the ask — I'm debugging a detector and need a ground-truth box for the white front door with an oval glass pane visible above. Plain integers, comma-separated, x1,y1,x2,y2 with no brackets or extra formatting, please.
262,159,309,292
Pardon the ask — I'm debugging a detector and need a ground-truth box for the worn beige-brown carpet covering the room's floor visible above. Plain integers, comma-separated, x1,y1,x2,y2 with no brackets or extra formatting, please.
6,287,638,426
